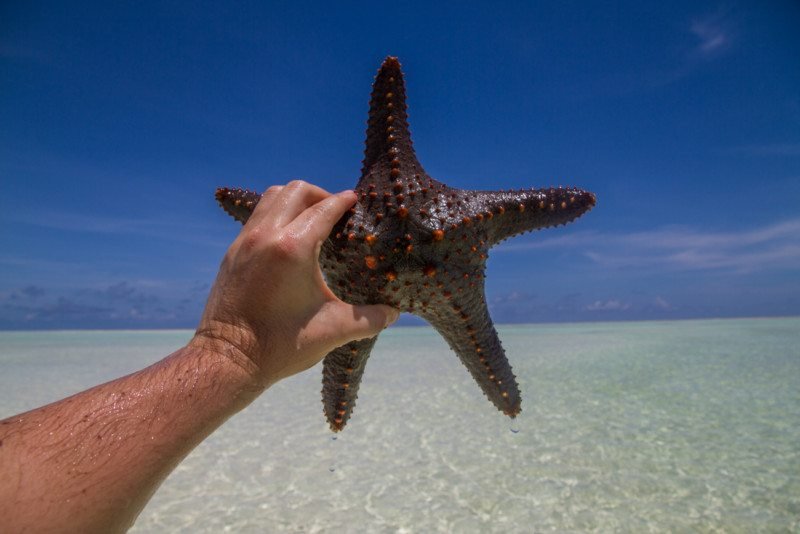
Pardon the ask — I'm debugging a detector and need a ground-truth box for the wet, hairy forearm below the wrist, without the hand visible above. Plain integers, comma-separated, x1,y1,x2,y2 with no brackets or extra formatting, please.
0,343,261,532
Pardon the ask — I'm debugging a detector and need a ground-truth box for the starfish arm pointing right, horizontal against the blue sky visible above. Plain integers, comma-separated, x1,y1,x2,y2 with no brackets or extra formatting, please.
462,187,596,246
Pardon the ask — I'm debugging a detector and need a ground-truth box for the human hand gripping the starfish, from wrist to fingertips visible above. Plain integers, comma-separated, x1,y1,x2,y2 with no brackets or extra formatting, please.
191,181,399,387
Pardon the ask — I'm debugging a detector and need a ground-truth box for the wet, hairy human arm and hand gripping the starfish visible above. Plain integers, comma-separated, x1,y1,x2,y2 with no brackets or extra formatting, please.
0,181,398,532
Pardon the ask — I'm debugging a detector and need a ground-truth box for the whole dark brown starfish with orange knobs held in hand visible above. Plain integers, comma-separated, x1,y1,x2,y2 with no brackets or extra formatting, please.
216,57,595,431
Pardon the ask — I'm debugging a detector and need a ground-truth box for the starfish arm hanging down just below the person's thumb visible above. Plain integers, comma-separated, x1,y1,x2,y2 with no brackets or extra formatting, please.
322,336,378,432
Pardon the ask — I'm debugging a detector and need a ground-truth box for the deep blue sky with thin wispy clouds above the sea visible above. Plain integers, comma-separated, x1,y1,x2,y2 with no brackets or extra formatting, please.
0,0,800,328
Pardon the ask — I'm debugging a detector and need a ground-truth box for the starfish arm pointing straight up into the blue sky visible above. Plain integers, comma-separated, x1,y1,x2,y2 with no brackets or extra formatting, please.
361,57,416,179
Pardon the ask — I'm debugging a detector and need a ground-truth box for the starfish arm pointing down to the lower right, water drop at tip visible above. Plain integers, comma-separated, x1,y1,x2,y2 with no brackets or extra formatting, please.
419,283,521,417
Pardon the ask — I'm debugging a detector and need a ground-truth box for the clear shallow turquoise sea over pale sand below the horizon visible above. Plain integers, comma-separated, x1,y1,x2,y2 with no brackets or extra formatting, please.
0,318,800,533
